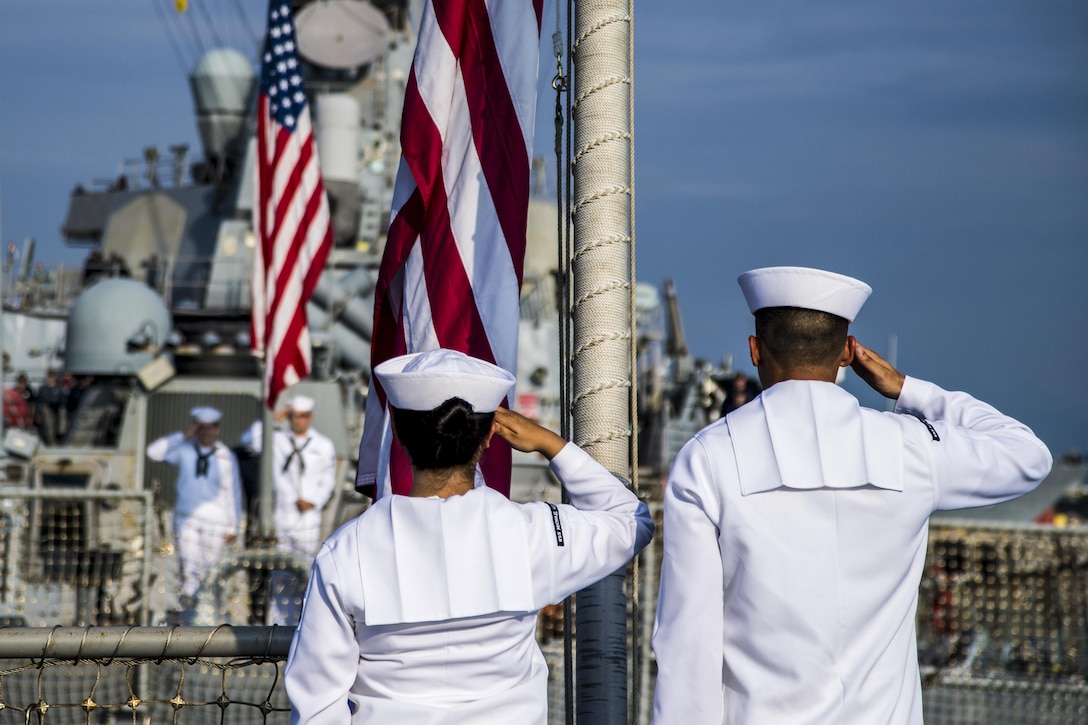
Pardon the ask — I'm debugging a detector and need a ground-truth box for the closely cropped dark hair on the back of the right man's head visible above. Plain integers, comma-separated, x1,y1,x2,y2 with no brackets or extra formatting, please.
755,307,850,366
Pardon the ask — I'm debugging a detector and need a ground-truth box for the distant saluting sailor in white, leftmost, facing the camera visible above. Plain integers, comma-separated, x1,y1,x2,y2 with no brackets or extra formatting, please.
147,407,242,610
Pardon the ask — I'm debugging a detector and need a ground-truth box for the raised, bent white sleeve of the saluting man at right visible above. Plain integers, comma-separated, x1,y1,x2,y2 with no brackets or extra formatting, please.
895,377,1053,511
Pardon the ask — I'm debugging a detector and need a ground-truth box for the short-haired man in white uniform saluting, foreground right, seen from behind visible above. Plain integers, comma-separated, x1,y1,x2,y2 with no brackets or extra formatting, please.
654,267,1052,725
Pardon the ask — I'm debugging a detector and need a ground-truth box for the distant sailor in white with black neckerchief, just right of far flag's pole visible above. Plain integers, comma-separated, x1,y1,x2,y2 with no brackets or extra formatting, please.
269,395,336,625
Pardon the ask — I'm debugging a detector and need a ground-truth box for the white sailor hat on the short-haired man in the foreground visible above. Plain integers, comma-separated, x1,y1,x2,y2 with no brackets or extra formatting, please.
737,267,873,322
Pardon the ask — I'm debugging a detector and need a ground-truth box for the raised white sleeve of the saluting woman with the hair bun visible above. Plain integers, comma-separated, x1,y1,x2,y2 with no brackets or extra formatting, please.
524,443,654,609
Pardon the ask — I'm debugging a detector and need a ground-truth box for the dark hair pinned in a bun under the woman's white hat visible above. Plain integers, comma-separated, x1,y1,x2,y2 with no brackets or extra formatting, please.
392,397,495,470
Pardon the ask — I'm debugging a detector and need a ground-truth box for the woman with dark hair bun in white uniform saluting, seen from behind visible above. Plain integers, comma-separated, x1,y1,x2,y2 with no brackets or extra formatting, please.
285,349,654,725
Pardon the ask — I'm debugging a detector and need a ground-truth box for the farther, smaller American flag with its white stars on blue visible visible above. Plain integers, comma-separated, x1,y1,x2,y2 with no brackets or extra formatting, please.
251,0,333,408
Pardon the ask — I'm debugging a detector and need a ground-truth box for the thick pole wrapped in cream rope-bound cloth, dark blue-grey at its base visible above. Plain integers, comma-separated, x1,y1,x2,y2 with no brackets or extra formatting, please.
570,0,635,725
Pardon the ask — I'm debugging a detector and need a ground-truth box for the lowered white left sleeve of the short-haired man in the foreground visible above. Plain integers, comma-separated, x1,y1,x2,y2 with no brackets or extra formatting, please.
654,438,725,723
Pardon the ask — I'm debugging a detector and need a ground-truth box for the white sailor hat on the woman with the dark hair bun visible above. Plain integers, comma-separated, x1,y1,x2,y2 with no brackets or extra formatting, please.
374,348,515,413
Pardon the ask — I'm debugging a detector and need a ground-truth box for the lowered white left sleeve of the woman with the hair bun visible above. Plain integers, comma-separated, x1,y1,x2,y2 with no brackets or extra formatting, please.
284,544,359,725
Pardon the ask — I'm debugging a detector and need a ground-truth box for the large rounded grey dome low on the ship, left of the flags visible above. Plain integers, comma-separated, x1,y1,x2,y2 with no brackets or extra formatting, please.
64,279,171,376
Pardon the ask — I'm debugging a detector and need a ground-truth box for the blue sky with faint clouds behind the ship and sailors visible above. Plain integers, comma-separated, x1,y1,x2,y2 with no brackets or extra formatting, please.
0,0,1088,454
